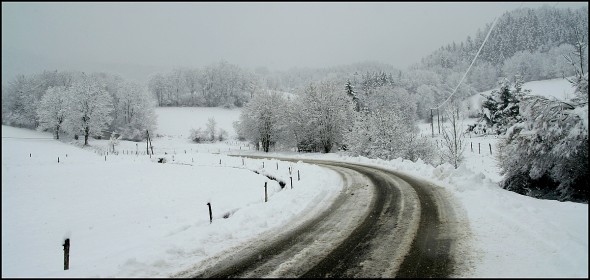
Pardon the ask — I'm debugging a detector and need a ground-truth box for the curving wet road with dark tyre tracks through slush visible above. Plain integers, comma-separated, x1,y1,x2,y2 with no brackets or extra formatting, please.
175,156,470,278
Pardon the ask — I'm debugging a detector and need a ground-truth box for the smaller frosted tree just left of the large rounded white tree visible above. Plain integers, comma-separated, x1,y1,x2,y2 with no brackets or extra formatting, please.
37,86,67,139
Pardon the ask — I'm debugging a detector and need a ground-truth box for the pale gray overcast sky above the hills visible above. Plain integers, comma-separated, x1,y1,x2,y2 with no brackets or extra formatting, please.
2,2,588,84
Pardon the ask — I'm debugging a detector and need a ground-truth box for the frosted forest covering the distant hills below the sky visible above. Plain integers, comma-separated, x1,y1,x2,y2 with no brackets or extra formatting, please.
2,6,588,127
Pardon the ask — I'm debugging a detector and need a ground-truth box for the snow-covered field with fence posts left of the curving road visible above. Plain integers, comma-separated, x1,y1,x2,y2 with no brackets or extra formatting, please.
2,126,341,277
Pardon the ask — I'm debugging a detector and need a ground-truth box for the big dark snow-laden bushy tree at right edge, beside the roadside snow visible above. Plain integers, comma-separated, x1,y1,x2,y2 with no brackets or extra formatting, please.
498,81,589,202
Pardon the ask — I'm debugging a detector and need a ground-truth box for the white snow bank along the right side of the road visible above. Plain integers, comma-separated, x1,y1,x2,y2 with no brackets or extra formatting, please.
262,153,588,278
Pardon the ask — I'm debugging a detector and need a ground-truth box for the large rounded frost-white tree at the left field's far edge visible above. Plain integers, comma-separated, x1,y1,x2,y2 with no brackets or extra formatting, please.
65,77,113,145
